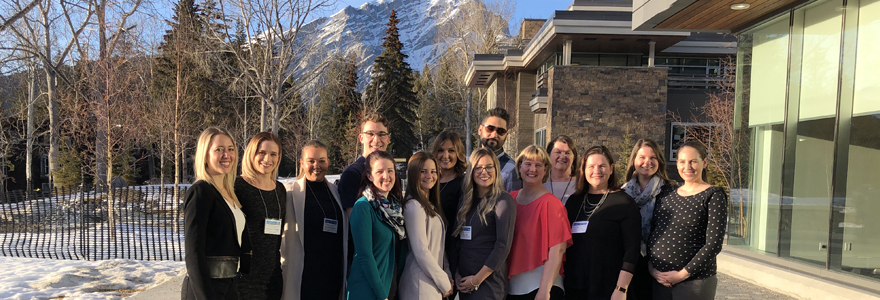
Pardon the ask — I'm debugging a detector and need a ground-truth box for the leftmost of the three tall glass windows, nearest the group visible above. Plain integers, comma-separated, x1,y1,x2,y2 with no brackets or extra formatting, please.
728,14,789,253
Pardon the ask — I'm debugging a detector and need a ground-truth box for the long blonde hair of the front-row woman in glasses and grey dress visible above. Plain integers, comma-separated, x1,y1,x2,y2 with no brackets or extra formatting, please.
452,148,507,236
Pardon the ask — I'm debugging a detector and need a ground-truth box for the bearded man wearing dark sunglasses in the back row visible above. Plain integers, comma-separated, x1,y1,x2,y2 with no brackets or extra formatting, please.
477,107,522,192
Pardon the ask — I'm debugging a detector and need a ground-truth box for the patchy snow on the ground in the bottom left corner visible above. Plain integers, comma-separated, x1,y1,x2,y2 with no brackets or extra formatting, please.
0,257,185,299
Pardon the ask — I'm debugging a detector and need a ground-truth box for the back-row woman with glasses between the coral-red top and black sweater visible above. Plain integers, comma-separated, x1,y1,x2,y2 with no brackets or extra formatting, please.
544,135,578,205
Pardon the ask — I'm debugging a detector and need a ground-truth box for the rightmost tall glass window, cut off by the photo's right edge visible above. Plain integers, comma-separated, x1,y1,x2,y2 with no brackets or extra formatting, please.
835,0,880,279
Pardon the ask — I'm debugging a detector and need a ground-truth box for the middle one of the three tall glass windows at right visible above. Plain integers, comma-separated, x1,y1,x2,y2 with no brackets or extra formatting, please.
783,0,843,266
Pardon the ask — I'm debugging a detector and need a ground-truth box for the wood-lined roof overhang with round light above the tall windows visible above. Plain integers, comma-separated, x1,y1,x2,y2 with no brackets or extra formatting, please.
632,0,810,32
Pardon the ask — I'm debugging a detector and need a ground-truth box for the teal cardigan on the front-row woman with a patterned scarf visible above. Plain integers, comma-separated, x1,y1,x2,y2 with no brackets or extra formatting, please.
346,197,397,300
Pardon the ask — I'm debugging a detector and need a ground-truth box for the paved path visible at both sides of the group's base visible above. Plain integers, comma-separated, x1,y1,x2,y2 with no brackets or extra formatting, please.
128,274,798,300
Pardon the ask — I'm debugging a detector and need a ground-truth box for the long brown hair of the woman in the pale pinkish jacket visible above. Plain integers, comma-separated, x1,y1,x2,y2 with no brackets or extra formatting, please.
406,151,446,223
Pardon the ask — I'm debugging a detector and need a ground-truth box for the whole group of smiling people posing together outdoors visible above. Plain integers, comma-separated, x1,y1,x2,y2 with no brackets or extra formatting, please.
181,108,727,300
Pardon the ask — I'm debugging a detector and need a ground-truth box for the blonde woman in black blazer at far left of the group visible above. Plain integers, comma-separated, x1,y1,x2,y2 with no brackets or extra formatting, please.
181,127,245,300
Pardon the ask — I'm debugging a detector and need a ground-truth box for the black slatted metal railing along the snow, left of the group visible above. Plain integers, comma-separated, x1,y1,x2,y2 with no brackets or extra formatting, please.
0,185,188,261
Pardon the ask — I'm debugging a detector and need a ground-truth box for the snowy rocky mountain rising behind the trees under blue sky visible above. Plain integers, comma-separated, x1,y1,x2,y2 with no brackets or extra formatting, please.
304,0,468,89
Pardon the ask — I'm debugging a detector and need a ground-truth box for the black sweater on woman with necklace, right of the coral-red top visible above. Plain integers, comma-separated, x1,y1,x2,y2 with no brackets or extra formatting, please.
564,191,641,299
